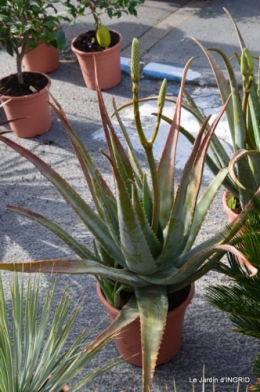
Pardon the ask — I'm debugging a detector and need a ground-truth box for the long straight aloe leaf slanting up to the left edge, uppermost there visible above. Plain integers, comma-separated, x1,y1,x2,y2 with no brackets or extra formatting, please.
0,135,124,265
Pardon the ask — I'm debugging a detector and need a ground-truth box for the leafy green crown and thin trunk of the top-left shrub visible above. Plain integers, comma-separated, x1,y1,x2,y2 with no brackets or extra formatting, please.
0,0,74,84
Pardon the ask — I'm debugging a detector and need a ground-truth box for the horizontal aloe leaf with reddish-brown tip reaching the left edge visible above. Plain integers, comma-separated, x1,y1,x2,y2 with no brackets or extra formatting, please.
0,259,146,287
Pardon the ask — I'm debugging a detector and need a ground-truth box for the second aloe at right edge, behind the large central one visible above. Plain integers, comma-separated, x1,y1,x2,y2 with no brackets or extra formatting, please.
146,8,260,219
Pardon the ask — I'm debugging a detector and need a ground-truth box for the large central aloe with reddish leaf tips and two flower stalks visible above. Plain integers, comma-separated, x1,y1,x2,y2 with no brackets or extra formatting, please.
0,39,256,391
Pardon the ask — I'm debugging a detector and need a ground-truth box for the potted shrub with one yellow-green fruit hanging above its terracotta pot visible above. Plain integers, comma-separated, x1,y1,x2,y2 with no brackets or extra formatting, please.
71,0,144,90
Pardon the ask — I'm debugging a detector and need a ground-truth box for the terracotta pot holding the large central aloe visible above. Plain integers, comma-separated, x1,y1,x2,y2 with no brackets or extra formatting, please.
97,283,195,367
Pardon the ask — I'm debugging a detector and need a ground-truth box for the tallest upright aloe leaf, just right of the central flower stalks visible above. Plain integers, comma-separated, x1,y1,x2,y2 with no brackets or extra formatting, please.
157,59,193,229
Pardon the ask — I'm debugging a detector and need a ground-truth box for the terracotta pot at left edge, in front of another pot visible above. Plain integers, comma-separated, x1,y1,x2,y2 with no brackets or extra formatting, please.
0,75,51,138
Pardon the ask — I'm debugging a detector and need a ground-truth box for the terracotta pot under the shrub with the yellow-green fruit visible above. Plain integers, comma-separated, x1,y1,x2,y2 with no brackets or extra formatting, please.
71,31,122,90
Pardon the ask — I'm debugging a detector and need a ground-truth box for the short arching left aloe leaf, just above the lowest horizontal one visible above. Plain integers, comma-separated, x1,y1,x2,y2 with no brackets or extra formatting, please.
6,205,99,261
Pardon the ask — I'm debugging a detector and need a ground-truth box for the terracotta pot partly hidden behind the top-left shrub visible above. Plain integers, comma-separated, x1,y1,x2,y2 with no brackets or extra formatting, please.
23,42,60,73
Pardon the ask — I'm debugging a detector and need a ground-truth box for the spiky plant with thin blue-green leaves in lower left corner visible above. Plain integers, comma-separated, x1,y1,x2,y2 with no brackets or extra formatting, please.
0,273,118,392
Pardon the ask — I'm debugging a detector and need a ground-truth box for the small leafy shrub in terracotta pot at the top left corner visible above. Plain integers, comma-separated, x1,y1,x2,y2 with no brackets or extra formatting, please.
0,0,74,137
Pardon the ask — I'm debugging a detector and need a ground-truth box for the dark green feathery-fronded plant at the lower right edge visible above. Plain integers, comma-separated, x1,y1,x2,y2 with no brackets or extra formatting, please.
206,199,260,391
